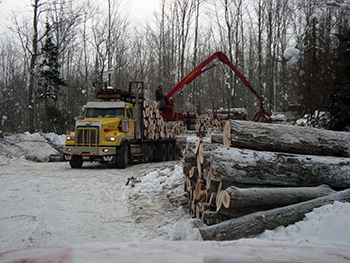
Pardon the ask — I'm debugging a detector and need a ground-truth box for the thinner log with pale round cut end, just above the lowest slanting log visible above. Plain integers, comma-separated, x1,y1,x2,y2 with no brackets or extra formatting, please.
216,185,335,218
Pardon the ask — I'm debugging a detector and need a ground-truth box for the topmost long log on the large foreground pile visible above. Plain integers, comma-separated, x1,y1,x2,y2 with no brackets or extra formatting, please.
224,120,350,157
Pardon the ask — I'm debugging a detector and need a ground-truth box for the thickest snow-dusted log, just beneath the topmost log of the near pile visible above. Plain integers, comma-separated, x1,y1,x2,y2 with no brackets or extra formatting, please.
212,148,350,189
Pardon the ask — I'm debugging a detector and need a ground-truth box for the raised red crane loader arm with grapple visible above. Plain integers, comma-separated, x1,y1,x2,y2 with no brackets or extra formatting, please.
160,52,272,123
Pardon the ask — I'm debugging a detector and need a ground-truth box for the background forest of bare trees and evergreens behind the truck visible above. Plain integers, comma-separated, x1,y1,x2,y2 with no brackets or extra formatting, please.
0,0,350,133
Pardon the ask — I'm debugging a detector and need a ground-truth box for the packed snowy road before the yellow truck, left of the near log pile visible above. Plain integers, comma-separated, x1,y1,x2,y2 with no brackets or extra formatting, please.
0,161,186,252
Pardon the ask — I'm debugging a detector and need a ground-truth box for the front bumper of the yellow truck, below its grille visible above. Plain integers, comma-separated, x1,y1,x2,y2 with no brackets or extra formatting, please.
63,146,116,162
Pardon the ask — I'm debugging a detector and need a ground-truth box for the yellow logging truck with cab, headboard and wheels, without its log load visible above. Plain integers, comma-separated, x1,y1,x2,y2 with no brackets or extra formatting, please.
63,82,176,168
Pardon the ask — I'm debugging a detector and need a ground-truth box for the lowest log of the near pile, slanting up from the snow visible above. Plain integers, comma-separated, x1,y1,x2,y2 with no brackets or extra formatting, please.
199,189,350,241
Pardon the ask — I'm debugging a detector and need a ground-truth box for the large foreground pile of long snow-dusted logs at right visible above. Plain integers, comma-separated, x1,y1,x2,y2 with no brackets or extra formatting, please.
183,120,350,240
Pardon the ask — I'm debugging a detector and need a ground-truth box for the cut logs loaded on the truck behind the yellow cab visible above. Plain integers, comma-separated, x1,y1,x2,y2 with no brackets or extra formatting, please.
142,96,185,140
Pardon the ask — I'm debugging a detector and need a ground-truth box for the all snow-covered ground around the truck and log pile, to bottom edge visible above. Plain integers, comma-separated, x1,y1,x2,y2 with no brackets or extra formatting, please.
0,134,350,262
